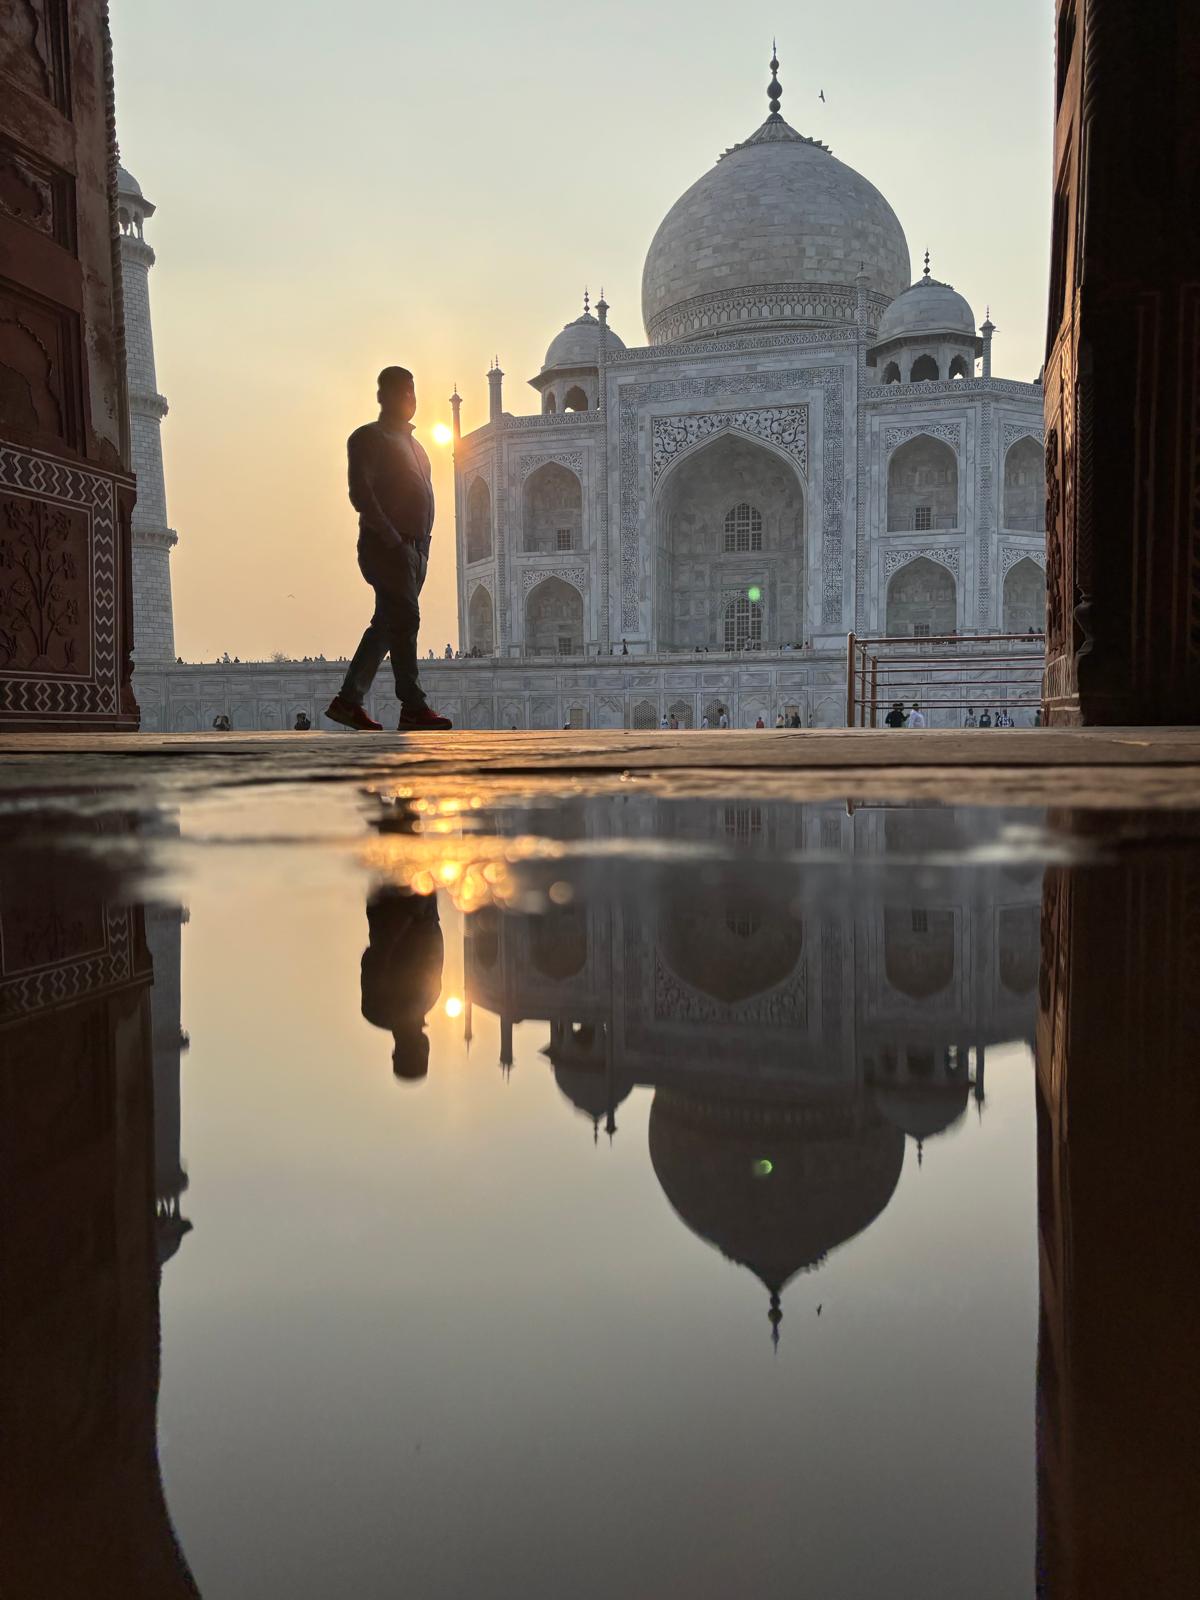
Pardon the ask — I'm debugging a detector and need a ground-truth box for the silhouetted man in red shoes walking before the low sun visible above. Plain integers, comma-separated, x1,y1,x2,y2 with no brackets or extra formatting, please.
325,366,453,733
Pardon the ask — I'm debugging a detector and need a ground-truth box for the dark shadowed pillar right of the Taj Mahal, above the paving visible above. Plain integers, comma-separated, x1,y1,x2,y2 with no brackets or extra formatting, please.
1045,0,1200,723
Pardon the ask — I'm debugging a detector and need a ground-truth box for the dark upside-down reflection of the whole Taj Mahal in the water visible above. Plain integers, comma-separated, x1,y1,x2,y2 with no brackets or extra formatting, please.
466,803,1042,1322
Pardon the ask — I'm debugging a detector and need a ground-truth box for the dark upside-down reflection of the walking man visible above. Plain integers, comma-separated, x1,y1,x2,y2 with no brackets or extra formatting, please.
363,888,443,1078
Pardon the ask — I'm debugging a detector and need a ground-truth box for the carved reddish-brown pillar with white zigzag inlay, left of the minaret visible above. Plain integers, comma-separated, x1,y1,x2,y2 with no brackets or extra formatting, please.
0,0,138,730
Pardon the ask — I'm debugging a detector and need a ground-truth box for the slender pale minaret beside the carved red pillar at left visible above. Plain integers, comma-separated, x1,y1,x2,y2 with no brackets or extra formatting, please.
117,166,179,666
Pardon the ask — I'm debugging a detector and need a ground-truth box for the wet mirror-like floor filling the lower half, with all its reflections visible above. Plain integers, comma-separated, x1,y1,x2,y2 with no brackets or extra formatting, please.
0,779,1197,1600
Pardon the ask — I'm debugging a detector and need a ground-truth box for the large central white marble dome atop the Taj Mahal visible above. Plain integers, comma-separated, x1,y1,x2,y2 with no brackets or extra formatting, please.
642,112,909,344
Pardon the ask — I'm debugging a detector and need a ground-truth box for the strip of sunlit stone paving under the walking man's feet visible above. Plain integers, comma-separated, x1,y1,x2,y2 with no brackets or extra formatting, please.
0,728,1200,806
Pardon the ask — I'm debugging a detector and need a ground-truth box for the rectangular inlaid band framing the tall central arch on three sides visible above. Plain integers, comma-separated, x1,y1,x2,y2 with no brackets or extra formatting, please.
618,365,846,632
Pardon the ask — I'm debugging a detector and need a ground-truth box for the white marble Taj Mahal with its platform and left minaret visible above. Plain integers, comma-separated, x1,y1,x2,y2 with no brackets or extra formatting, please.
120,58,1045,731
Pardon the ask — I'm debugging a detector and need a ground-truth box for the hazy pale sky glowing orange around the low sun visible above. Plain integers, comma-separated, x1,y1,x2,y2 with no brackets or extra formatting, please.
112,0,1053,661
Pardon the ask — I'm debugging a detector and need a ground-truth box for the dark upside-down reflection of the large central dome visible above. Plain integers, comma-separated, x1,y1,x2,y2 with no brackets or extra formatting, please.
650,1088,904,1294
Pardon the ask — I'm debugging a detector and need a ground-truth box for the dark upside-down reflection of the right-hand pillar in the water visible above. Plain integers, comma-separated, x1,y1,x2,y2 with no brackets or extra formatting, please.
1037,813,1200,1600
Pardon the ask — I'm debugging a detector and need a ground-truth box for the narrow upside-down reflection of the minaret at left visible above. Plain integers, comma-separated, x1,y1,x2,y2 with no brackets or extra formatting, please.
146,906,192,1266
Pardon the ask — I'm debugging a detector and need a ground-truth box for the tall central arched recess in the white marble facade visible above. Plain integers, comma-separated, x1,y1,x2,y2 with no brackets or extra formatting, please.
654,430,805,650
